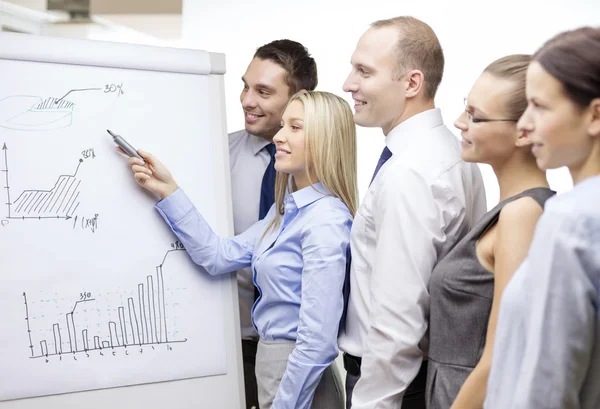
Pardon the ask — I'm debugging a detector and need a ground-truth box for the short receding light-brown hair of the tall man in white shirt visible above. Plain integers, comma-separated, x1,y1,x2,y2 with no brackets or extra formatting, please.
371,16,444,99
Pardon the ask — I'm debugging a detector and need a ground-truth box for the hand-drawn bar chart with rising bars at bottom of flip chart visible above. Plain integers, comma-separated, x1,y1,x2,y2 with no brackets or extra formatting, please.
23,245,187,359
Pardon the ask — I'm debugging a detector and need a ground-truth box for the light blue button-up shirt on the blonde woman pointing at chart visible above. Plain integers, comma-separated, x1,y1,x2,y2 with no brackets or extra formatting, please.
156,183,352,409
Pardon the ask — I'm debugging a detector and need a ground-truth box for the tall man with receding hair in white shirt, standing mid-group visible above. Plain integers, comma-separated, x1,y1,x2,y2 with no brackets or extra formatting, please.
339,17,486,409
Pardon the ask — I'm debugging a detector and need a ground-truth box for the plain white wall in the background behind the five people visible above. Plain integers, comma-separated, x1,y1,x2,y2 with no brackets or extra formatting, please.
183,0,600,207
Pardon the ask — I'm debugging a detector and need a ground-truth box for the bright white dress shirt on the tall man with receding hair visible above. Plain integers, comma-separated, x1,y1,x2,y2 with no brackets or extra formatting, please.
339,109,486,409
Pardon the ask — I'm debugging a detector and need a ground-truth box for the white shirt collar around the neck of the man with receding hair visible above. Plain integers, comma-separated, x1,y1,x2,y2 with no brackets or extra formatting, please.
385,108,444,154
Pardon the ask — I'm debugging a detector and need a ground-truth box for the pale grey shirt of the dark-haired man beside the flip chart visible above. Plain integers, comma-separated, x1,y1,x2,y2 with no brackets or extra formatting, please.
229,130,271,339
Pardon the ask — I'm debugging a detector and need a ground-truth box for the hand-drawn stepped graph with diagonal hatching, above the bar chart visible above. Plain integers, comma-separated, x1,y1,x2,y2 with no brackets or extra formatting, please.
1,143,83,220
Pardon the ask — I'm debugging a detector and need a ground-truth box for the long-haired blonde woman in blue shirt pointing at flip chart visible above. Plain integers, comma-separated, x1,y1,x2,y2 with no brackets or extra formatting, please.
120,92,357,409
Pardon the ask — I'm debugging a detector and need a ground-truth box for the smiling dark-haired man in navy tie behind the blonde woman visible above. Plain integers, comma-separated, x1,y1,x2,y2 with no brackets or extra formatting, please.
229,40,317,409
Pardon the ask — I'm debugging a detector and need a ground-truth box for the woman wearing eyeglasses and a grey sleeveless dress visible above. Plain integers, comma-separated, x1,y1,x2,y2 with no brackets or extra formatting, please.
426,55,554,409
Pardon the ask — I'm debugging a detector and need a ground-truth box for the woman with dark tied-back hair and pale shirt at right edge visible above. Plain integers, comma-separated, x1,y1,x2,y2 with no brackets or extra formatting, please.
485,27,600,409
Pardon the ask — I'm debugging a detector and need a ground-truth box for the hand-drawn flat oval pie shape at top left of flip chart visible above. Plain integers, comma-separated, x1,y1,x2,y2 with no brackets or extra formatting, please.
0,95,75,131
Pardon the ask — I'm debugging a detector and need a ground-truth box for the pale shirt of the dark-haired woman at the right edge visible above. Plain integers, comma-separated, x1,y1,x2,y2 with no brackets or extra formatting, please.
484,176,600,409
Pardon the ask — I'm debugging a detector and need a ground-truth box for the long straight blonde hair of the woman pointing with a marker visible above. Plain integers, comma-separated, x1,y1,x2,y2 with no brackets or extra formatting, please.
263,91,358,237
